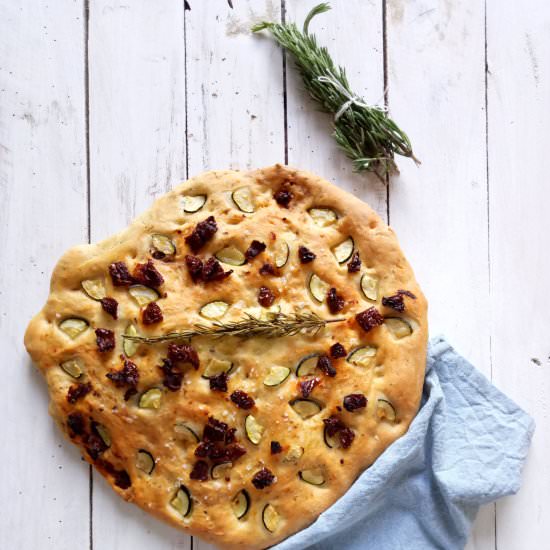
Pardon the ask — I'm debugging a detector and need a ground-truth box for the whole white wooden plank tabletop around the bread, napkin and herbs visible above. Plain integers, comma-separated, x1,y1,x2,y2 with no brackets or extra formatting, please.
0,0,550,550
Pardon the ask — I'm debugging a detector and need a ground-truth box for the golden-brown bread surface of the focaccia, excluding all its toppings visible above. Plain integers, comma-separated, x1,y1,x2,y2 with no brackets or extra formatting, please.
25,165,427,549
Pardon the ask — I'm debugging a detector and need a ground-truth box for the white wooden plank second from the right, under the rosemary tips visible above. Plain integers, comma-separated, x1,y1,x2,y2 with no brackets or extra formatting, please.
386,0,495,550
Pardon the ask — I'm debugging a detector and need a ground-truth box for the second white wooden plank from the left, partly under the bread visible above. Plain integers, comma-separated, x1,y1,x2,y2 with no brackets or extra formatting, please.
89,0,191,550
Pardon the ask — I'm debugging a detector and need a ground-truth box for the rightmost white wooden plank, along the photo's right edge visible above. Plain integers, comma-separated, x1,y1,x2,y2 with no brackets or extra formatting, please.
487,0,550,550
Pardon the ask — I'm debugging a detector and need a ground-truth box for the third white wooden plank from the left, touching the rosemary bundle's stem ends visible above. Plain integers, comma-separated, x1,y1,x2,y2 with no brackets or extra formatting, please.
186,0,284,550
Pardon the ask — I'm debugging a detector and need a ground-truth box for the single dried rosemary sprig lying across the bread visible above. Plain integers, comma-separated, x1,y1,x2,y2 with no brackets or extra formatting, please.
123,312,345,344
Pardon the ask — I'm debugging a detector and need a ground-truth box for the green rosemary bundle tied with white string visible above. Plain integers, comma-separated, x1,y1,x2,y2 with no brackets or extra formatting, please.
252,3,418,181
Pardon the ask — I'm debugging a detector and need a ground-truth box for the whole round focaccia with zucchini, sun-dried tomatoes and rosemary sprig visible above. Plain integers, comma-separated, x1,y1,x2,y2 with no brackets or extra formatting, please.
25,165,427,549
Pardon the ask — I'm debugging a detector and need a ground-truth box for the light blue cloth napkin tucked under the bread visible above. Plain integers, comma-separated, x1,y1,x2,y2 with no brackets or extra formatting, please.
275,337,535,550
